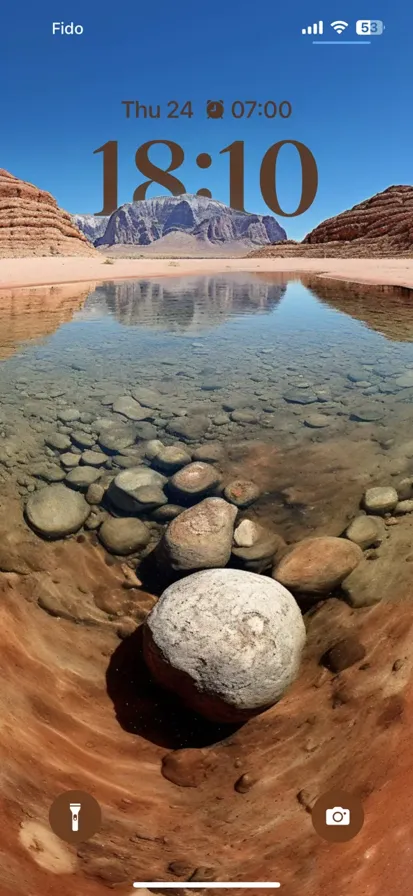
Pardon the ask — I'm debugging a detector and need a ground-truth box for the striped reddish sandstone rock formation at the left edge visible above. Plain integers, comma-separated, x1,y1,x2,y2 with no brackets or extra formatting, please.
0,168,96,258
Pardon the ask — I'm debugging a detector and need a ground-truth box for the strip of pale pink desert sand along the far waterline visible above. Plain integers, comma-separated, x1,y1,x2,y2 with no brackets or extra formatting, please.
0,256,413,295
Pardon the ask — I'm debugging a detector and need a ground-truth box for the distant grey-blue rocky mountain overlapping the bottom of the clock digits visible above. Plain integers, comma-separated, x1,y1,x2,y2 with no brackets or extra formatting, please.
72,193,287,251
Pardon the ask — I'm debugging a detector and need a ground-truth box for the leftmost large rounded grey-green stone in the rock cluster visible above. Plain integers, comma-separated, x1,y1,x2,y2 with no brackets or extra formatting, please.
26,484,90,538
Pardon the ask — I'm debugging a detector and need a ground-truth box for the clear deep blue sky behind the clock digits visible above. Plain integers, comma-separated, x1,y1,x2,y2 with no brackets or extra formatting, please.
0,0,413,239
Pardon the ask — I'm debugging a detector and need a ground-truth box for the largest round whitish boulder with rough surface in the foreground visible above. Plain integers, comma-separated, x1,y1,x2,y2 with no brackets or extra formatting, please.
144,569,305,722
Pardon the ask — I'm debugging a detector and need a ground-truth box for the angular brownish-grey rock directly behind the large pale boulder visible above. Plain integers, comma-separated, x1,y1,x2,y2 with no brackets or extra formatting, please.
162,498,237,571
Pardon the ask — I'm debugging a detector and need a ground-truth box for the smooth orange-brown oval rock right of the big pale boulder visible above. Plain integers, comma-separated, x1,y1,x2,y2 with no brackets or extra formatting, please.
272,535,363,594
